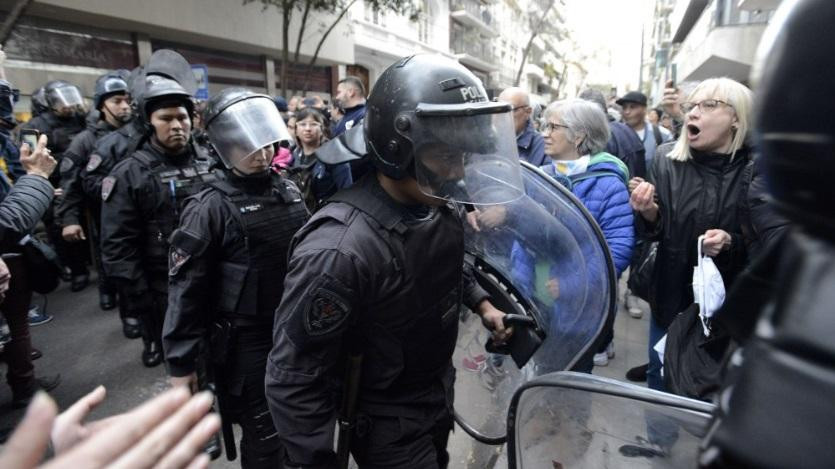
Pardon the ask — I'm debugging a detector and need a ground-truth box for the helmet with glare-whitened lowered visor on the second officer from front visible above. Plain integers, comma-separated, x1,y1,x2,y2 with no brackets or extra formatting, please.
203,88,290,169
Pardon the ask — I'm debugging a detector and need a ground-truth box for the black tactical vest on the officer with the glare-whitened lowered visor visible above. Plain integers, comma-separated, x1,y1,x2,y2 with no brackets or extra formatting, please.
210,175,309,321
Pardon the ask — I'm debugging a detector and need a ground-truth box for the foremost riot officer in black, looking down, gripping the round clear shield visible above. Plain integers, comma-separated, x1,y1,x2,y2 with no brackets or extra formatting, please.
266,55,522,468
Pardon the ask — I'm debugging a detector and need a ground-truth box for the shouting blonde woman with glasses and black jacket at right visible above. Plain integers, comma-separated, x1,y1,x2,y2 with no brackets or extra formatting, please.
630,78,751,389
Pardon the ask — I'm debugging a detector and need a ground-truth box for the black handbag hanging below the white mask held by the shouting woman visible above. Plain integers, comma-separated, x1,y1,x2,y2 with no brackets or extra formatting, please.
664,303,732,401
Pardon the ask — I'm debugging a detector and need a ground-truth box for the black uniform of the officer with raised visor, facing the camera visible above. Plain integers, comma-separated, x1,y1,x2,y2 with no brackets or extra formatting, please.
101,143,216,364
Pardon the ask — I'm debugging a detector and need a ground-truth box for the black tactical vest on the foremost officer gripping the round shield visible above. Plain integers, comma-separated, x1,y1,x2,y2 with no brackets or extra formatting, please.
328,177,464,400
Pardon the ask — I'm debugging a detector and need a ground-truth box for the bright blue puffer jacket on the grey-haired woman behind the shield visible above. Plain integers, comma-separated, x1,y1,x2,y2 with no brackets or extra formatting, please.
542,153,635,276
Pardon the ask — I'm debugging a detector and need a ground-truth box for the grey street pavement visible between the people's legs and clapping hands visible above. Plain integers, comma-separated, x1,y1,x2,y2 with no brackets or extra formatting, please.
0,272,648,469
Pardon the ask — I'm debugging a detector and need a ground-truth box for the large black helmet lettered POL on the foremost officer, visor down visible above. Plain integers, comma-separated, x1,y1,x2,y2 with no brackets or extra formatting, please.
364,54,522,203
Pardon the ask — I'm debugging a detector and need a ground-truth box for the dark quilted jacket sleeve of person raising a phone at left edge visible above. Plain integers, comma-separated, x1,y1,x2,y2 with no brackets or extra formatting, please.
0,175,53,252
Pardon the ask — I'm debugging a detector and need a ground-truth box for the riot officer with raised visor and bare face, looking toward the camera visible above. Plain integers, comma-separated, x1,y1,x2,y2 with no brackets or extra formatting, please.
101,75,214,367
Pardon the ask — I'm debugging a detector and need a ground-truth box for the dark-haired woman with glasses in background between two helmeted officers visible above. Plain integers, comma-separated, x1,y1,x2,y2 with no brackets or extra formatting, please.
287,107,353,213
